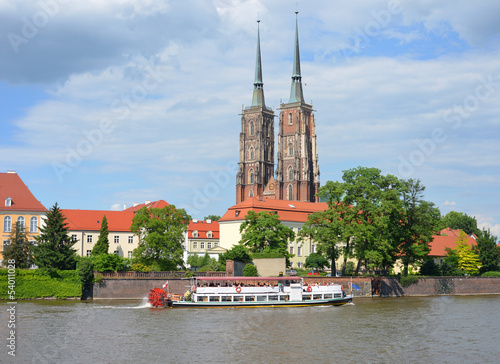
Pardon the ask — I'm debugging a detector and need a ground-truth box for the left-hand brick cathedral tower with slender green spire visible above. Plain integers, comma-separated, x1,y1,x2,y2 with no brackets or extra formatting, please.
236,21,274,203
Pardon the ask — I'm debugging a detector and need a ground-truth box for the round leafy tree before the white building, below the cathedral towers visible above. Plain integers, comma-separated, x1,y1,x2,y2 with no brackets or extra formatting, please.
240,210,295,266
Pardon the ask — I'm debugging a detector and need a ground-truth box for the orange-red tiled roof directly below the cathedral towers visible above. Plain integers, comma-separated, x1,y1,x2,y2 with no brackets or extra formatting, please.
219,197,328,222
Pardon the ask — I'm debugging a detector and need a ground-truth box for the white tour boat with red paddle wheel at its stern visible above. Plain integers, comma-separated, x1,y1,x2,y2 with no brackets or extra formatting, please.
149,277,352,308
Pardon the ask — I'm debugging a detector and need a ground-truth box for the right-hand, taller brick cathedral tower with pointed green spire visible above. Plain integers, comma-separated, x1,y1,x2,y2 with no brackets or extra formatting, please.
275,12,319,202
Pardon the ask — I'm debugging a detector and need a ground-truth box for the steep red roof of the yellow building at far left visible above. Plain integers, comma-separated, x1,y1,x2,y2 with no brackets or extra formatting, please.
0,172,47,211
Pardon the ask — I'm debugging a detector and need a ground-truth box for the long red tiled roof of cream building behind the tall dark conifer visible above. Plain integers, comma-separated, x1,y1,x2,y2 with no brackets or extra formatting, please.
62,210,134,231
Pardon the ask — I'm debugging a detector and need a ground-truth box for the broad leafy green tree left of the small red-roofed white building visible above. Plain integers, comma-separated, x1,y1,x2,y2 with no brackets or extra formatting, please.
130,205,191,270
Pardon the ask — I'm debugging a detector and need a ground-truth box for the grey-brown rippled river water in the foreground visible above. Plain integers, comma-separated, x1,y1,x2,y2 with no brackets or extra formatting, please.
0,295,500,363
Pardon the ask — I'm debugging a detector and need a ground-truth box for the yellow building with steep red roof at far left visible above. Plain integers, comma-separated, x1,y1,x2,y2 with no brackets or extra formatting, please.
0,171,47,260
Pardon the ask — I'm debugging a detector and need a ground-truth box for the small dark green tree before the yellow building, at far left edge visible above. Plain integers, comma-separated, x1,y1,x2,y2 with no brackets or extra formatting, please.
2,221,33,269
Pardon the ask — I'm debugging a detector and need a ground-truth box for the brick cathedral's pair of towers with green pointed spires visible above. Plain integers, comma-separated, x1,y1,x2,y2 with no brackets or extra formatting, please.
236,13,319,204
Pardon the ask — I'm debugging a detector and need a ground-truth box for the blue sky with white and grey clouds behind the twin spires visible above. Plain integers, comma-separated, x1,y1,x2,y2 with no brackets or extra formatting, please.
0,0,500,237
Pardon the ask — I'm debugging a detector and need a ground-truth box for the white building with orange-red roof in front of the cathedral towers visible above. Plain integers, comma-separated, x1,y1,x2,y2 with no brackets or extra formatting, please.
219,197,341,268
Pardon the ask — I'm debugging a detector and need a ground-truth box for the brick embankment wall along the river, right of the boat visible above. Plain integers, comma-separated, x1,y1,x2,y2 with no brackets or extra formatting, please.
373,277,500,297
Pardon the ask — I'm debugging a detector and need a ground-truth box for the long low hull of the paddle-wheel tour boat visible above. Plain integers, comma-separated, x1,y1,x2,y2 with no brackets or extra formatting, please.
167,296,352,308
